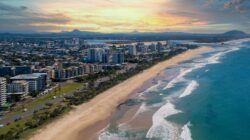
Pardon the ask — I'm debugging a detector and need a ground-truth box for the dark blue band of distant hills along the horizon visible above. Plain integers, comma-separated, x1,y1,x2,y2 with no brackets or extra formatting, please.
0,29,250,42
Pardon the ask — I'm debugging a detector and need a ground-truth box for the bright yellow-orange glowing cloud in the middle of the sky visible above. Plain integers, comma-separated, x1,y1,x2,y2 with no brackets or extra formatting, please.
28,0,210,32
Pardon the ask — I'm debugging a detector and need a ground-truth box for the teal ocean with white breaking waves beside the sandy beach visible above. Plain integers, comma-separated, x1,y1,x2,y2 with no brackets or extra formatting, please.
99,39,250,140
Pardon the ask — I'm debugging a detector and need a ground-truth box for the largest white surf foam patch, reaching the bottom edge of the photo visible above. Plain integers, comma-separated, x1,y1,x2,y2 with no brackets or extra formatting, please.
146,102,181,140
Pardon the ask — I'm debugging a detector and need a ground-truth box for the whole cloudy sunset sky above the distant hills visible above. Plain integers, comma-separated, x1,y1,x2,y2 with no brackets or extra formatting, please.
0,0,250,33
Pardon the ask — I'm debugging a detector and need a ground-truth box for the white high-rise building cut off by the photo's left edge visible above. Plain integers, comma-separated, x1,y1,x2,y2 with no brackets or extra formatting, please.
0,77,7,106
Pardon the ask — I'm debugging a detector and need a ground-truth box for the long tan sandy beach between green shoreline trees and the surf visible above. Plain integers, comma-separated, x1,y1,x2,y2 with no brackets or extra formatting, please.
30,47,210,140
